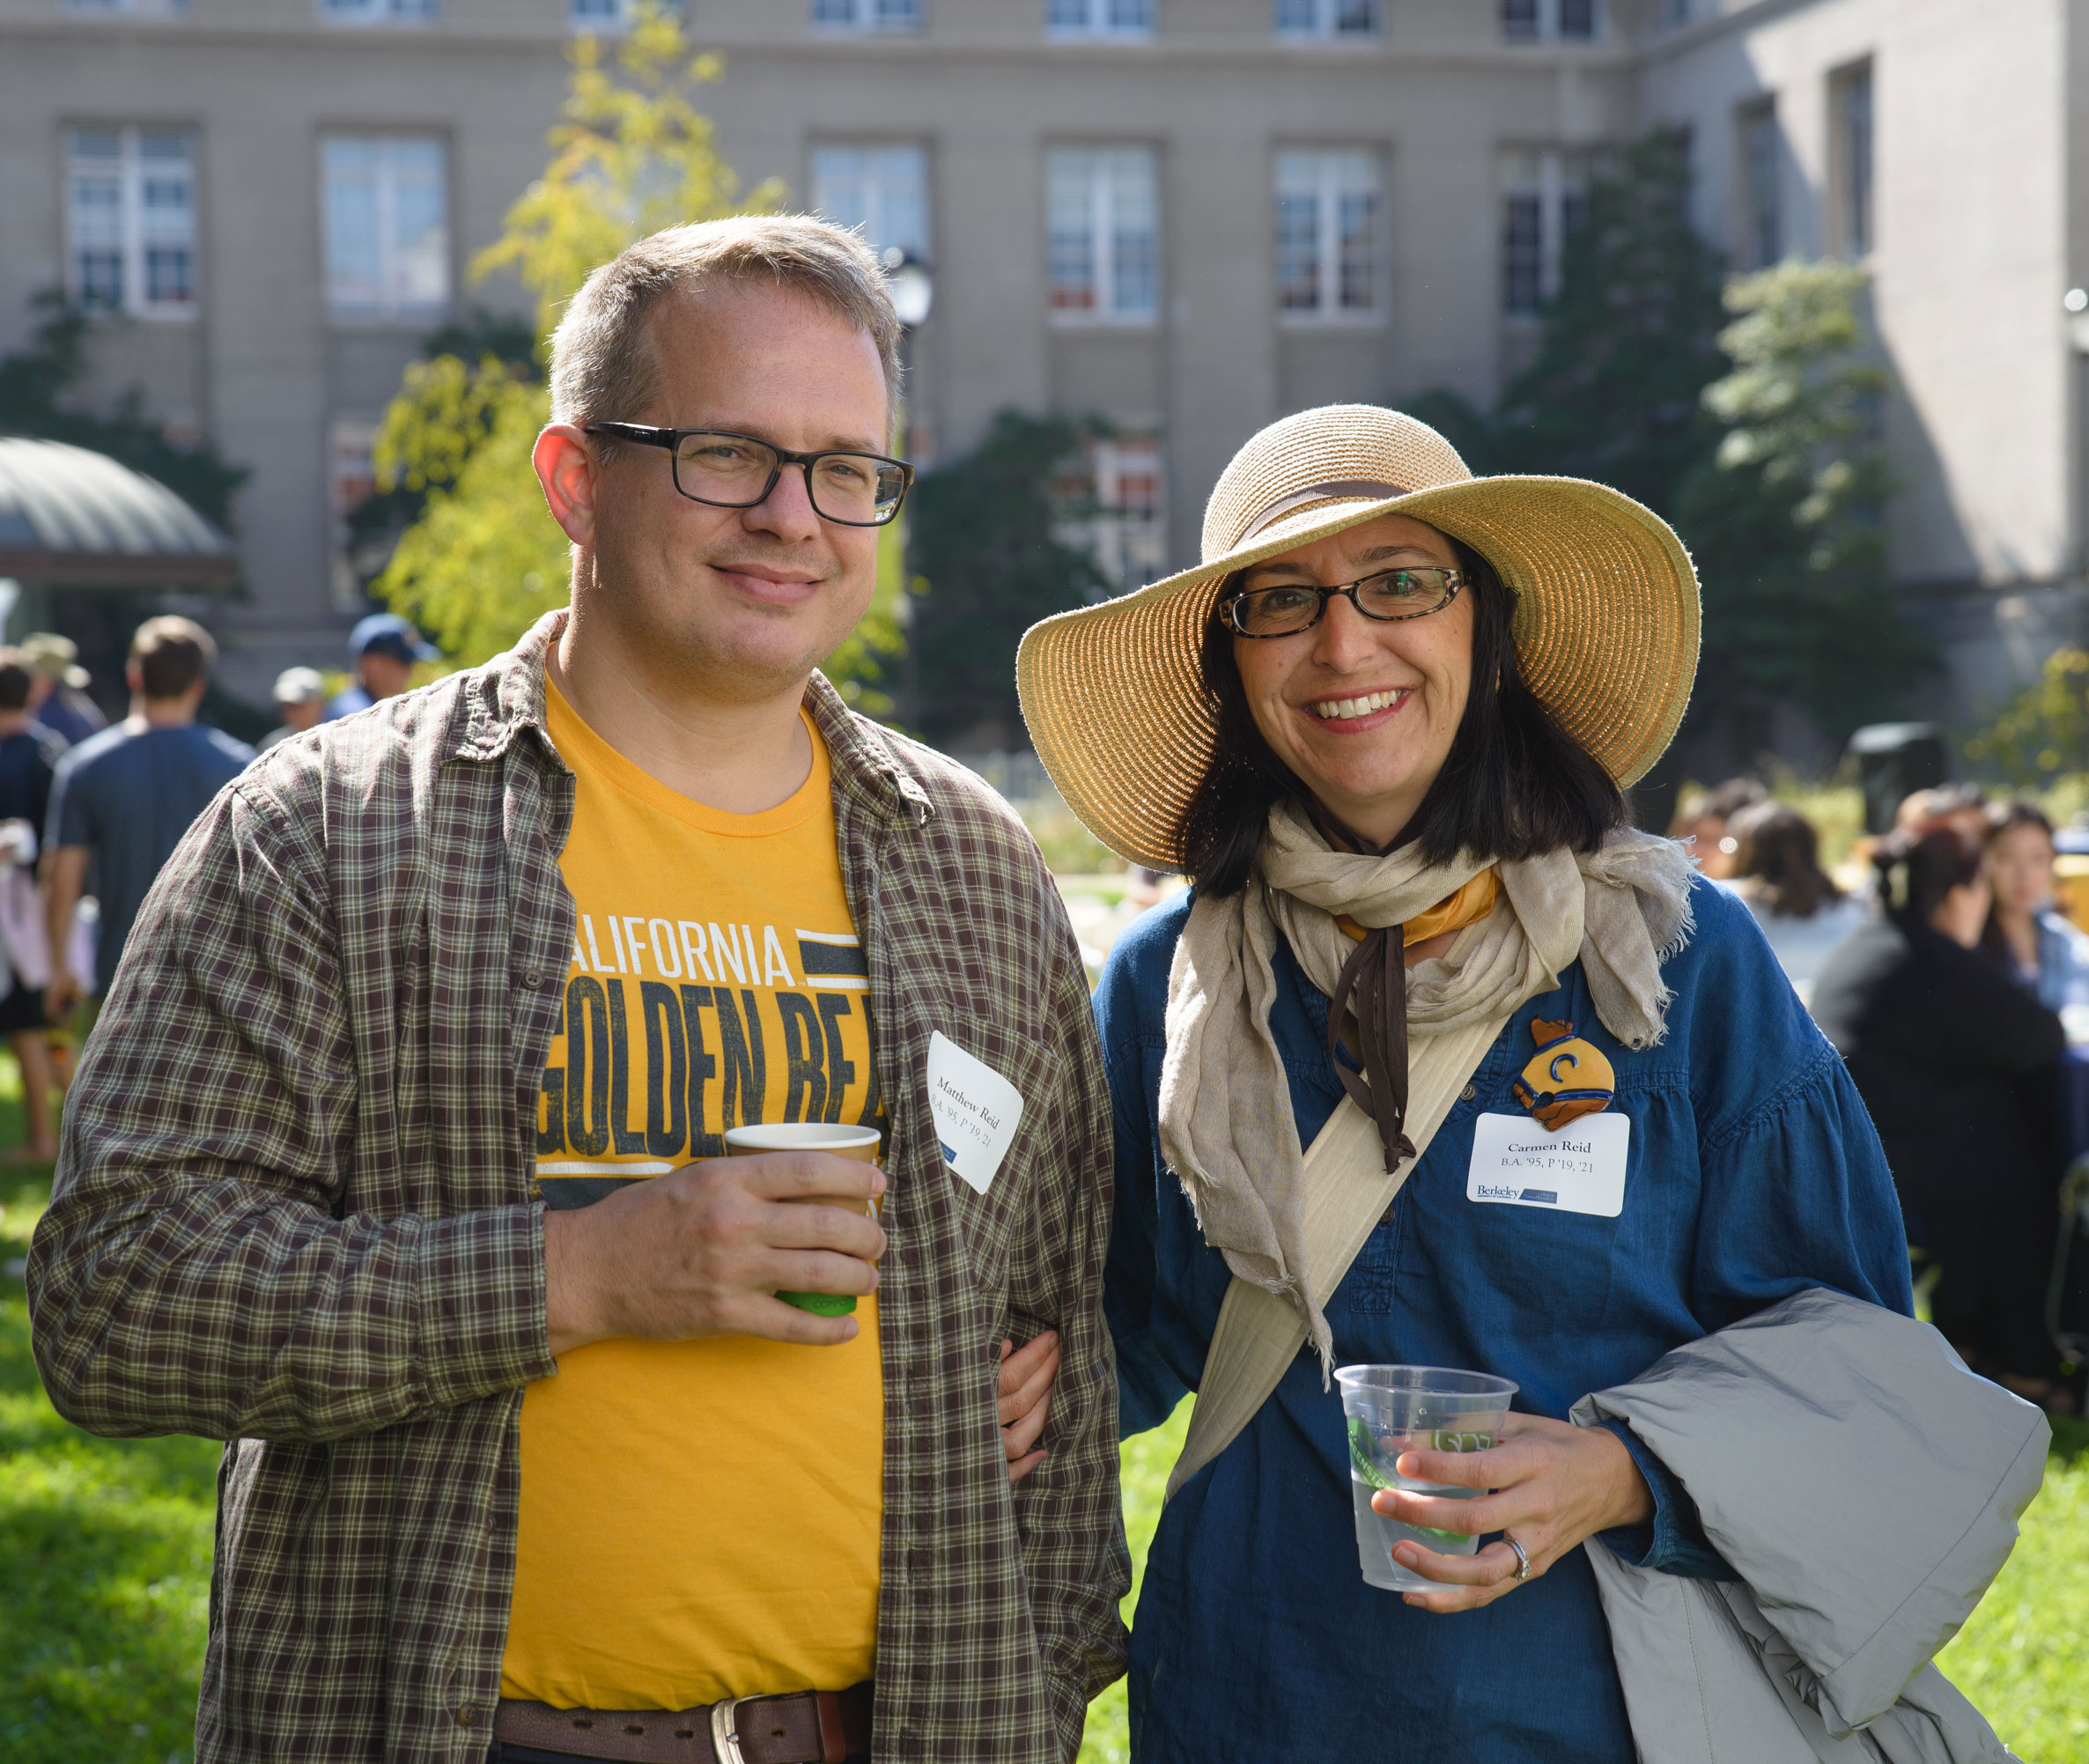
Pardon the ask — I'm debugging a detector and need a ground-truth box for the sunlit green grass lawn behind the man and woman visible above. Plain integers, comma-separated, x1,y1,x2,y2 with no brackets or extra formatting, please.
0,1137,2089,1764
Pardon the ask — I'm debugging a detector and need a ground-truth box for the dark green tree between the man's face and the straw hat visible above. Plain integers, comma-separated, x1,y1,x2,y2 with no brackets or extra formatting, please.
909,410,1111,742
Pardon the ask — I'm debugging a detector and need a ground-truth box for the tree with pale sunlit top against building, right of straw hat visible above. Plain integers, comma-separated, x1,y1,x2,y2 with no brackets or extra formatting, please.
1678,262,1932,740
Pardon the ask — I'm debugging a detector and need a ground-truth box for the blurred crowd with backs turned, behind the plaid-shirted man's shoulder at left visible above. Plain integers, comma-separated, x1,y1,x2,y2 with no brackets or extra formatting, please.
0,612,437,1162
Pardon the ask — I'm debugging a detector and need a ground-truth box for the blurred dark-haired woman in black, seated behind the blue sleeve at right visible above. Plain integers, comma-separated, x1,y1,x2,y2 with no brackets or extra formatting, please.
1813,822,2066,1402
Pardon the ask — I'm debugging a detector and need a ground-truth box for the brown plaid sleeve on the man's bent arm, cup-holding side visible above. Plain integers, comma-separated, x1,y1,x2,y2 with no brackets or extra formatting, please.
29,790,556,1440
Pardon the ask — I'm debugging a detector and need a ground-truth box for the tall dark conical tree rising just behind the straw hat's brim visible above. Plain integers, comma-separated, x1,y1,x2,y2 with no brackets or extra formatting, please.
1410,129,1724,514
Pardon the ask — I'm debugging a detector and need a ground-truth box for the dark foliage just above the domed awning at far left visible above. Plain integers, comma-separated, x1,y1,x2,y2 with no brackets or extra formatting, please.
0,292,247,527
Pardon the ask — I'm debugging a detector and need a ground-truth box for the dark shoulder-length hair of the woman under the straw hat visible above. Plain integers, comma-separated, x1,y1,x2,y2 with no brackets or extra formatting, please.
1176,539,1628,898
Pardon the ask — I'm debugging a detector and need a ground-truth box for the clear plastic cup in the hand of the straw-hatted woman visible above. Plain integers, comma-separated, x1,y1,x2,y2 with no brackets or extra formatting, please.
1335,1367,1517,1592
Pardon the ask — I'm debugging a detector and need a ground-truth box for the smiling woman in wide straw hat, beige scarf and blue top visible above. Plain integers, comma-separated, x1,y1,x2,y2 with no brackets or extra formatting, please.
1017,405,1911,1764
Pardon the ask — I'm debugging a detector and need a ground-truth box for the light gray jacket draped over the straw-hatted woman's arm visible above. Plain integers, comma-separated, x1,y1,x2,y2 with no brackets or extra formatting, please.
1571,1288,2051,1764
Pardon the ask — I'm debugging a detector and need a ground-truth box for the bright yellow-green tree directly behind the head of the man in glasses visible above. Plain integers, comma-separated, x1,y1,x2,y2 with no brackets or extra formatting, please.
372,6,801,677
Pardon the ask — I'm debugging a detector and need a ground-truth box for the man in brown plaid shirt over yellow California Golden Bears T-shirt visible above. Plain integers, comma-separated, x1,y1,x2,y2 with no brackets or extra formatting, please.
29,218,1128,1764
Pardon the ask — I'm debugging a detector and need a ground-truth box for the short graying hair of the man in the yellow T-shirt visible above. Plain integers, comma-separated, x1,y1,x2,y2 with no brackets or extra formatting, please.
551,215,900,445
